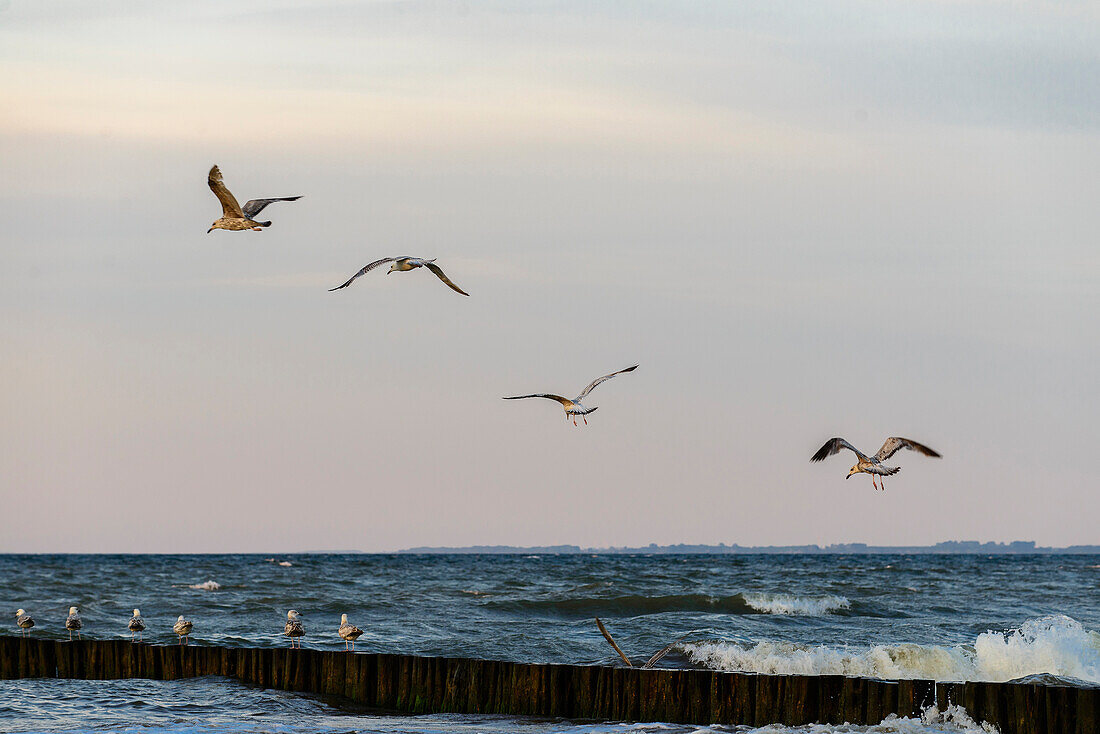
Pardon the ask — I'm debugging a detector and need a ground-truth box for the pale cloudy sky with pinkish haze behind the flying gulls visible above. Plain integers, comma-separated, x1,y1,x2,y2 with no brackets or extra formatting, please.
0,0,1100,552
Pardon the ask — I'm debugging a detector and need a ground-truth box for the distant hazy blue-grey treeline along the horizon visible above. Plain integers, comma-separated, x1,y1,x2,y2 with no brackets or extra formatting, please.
397,540,1100,556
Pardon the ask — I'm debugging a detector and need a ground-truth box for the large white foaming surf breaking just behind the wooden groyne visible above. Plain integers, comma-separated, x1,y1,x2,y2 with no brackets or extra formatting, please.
684,615,1100,682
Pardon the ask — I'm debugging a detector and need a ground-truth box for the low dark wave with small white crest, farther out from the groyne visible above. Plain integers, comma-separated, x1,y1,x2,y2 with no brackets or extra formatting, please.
485,593,851,617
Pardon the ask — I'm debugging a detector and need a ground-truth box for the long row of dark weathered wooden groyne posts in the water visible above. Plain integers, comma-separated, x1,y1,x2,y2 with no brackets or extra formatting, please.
0,636,1100,734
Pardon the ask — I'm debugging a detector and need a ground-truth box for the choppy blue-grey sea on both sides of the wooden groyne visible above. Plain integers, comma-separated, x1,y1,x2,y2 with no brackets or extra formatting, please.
0,554,1100,734
